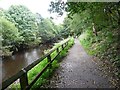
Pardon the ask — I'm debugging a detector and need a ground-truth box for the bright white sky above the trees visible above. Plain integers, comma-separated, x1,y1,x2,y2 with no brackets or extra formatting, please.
0,0,66,24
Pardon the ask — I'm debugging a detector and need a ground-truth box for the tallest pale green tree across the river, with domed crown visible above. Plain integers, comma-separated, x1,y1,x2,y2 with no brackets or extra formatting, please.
8,5,40,45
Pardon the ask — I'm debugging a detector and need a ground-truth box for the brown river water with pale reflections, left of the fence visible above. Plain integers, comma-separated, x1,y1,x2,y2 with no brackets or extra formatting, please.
0,45,51,81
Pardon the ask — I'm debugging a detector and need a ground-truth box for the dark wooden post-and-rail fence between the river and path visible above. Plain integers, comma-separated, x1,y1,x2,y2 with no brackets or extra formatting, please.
2,39,69,90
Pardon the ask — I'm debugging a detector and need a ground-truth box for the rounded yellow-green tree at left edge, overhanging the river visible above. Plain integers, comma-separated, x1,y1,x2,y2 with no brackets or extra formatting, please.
0,18,23,50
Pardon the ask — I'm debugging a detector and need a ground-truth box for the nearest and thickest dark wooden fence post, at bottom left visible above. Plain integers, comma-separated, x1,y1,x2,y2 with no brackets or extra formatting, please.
20,69,28,90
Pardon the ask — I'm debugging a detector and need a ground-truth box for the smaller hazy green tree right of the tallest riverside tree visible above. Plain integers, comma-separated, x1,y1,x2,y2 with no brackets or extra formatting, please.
38,18,59,42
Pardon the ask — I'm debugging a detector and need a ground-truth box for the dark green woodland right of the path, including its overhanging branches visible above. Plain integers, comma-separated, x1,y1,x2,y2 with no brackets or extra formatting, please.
49,1,120,77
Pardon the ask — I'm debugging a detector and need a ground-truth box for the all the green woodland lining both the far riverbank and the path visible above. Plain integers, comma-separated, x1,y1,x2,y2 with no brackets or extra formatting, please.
0,0,120,78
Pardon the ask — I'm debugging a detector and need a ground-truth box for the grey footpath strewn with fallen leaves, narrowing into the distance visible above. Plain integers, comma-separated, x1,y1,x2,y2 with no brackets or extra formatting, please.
42,40,119,88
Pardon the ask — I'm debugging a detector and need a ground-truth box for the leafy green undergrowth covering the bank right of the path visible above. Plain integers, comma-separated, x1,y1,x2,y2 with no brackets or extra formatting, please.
79,29,120,78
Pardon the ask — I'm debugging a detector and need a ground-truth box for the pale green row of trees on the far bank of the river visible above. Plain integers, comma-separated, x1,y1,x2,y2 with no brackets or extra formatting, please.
0,5,67,55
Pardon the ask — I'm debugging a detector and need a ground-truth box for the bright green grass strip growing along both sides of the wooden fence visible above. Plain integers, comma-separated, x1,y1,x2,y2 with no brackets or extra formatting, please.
11,38,74,89
